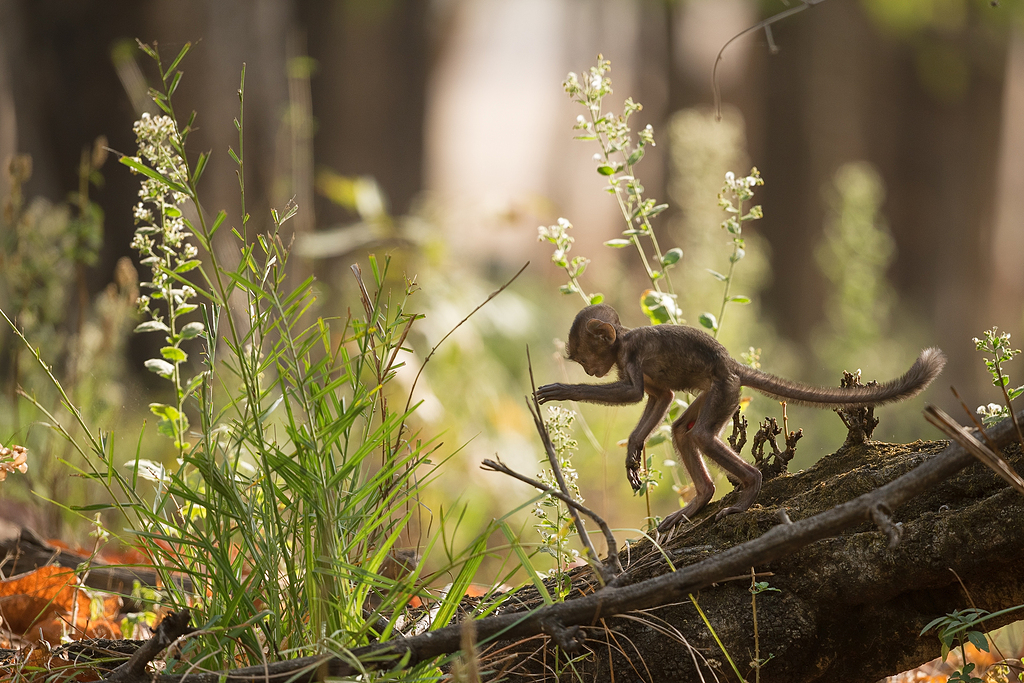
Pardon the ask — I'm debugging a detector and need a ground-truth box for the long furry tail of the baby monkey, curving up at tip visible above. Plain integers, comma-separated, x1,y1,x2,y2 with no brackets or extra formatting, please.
735,348,946,410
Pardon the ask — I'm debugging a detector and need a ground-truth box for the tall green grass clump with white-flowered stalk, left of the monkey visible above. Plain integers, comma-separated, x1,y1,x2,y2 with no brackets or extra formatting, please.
4,45,499,675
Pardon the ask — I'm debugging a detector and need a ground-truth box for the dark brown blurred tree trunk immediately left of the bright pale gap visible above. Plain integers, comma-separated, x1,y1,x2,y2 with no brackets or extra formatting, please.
298,0,430,224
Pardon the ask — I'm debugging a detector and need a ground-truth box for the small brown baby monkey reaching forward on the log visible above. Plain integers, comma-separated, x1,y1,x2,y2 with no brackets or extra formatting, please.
537,304,946,531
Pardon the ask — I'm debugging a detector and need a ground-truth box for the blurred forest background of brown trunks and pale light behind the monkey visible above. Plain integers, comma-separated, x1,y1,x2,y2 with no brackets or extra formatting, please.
0,0,1024,561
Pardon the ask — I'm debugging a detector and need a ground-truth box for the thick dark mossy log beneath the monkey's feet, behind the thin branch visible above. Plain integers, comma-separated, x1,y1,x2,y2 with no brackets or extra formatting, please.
493,441,1024,683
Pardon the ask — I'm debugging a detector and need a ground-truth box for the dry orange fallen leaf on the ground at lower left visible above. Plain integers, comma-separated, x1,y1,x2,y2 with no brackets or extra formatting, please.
0,566,121,645
